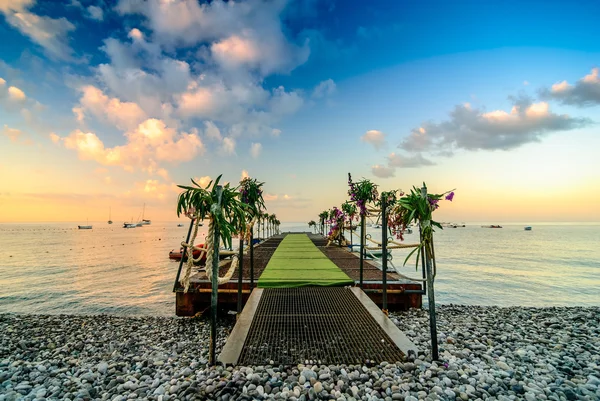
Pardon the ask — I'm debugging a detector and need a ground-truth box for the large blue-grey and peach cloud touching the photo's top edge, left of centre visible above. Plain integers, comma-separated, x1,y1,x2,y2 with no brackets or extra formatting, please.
117,0,309,75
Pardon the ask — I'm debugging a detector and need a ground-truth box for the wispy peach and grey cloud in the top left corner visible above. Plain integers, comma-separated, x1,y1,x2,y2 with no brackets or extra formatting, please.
0,0,75,60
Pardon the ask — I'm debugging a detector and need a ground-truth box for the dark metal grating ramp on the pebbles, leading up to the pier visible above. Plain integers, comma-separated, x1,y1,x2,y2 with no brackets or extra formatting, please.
238,287,404,366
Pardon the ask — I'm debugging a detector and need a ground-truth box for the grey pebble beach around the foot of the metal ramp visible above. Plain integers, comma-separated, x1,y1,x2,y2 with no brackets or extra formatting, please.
0,305,600,401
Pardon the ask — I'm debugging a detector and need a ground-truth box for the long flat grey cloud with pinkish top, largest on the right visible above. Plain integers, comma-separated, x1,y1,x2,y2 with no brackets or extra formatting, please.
399,96,591,152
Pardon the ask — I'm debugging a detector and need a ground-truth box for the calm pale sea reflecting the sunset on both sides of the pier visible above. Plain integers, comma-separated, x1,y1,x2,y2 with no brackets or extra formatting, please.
0,222,600,315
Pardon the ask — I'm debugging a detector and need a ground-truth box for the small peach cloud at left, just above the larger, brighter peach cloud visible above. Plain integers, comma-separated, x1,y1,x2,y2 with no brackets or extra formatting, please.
73,85,147,130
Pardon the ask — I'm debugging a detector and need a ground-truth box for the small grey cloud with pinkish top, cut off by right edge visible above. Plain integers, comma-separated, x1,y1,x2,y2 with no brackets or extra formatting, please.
541,68,600,107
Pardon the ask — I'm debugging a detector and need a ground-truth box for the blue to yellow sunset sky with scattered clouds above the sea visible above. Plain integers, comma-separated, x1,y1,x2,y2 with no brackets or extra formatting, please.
0,0,600,223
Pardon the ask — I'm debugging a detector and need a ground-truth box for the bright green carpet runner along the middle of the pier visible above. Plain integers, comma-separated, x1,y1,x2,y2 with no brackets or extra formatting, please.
258,234,354,288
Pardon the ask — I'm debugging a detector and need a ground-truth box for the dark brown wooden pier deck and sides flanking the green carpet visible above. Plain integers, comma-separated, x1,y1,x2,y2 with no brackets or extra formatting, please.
173,232,424,316
